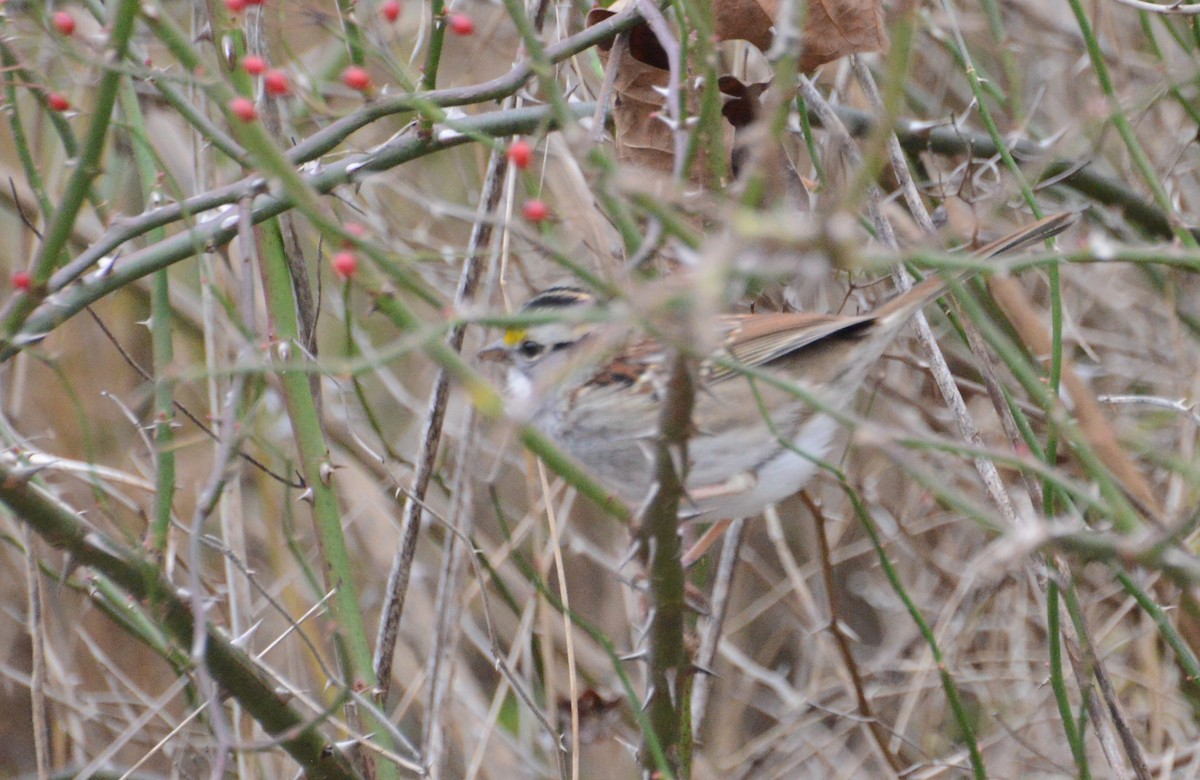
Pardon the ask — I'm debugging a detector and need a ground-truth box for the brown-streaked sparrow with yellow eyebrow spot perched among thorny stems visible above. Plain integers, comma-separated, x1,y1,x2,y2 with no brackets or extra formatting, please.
479,212,1076,520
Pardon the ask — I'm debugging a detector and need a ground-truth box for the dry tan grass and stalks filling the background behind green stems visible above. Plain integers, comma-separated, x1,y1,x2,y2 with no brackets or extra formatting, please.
0,0,1200,780
